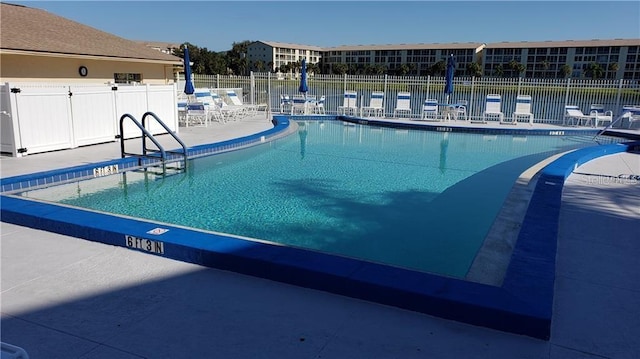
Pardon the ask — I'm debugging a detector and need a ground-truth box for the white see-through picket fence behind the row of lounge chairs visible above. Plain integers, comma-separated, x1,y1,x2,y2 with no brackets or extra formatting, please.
177,73,640,124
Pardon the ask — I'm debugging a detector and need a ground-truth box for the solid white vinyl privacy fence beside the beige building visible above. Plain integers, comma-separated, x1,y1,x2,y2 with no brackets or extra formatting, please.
0,82,178,157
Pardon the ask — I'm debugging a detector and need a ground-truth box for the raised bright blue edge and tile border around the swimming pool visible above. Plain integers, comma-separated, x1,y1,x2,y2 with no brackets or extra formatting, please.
0,115,640,340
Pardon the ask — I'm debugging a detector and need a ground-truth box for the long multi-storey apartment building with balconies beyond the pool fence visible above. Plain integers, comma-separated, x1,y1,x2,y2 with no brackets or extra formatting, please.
248,39,640,80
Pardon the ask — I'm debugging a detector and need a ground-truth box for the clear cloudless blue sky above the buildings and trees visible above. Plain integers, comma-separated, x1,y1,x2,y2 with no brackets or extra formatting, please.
2,0,640,52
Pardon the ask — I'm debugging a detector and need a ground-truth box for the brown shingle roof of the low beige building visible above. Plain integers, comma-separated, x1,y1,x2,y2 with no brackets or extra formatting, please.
0,3,182,64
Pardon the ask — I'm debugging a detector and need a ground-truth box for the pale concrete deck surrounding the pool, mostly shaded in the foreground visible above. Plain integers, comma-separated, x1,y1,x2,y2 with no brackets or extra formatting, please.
0,118,640,358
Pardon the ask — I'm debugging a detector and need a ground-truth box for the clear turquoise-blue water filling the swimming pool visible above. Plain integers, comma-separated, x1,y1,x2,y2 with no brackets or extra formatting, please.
22,121,590,278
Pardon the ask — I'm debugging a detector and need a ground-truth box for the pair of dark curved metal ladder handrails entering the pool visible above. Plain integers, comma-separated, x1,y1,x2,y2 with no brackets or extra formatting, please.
119,112,187,174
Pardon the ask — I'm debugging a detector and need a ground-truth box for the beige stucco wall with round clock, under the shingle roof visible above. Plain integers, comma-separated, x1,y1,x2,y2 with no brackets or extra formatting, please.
0,54,174,85
